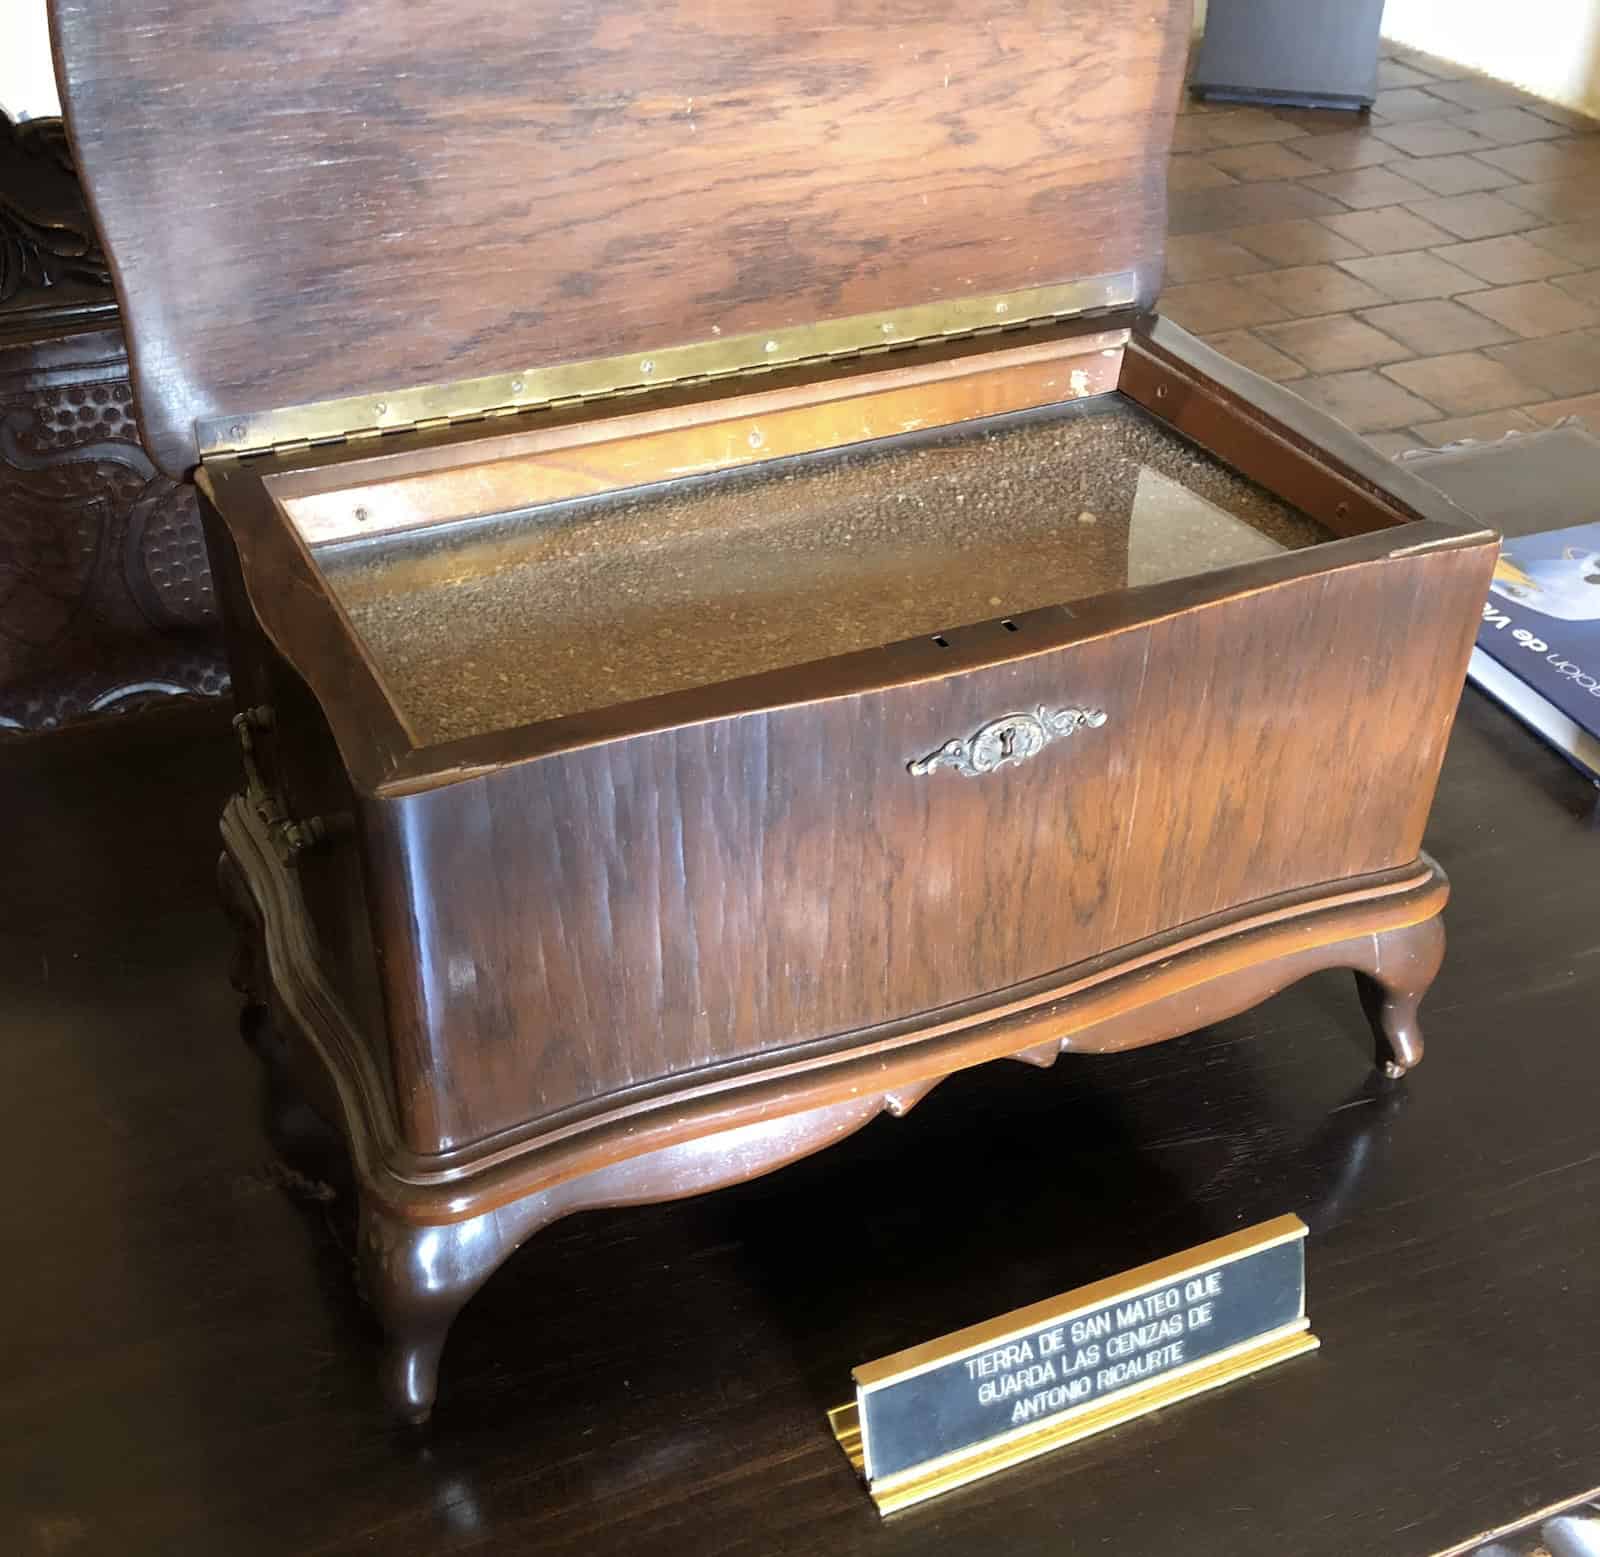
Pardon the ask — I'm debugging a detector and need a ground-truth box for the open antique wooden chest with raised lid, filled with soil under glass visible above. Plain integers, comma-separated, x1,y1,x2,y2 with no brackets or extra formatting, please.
54,0,1494,1419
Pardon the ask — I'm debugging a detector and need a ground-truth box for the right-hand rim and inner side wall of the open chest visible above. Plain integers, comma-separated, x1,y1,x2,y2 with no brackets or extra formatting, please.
1118,315,1494,542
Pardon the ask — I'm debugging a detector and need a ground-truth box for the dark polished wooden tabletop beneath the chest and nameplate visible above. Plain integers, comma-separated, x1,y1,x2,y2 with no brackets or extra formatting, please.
0,693,1600,1557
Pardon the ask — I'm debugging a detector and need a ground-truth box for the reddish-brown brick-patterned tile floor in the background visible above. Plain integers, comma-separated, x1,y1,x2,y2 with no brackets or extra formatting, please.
1162,45,1600,453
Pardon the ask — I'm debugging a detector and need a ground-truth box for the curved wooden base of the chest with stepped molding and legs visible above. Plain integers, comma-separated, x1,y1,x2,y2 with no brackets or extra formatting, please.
219,800,1448,1421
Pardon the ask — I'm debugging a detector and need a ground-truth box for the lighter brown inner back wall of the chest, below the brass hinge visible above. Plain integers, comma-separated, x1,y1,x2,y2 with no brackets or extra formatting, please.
278,331,1128,546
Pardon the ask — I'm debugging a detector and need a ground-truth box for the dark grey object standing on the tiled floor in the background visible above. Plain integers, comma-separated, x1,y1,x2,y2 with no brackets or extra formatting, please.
1189,0,1384,109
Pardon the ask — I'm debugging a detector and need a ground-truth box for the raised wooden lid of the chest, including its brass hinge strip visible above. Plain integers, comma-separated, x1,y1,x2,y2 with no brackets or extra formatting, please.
51,0,1192,475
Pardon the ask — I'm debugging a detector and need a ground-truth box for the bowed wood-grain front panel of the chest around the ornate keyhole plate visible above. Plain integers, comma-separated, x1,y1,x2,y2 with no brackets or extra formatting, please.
368,544,1493,1152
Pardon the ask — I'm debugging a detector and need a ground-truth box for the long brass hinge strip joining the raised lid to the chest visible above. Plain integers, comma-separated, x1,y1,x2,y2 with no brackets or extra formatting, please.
195,270,1138,459
